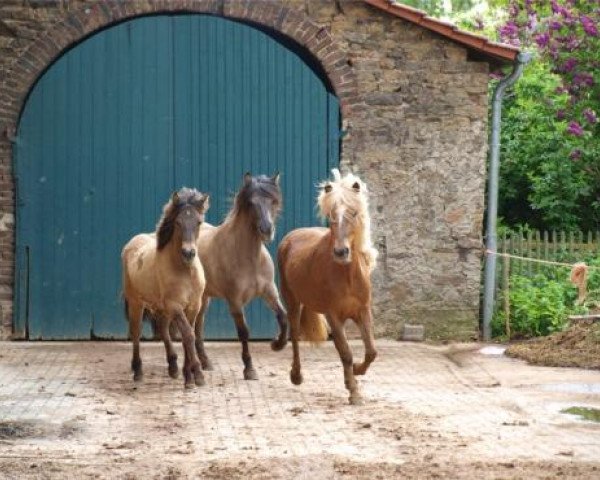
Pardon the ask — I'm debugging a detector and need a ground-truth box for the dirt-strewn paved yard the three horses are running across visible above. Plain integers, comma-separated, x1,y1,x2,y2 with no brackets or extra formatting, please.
0,341,600,480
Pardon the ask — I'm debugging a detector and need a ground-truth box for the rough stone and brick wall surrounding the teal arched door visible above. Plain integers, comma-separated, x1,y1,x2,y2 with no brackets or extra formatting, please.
0,0,488,339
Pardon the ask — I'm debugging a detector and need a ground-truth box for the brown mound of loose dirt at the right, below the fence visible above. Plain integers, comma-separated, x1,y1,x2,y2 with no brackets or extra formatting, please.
506,321,600,370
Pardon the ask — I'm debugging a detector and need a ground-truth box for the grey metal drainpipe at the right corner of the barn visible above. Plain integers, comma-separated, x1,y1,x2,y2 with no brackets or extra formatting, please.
483,52,533,341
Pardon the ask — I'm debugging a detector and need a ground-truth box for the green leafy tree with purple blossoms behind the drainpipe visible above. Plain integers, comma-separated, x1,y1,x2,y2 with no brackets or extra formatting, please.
496,0,600,230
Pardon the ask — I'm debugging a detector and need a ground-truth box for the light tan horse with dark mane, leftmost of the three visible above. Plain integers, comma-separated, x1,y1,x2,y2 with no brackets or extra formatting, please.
121,188,208,388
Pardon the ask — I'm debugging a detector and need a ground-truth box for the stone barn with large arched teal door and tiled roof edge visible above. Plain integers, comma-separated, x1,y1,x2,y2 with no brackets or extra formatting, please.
0,0,518,339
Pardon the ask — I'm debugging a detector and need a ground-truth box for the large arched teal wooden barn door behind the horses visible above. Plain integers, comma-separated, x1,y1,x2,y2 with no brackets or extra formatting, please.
14,15,339,339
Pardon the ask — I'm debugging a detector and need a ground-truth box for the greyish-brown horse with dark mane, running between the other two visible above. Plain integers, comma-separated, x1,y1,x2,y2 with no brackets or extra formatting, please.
196,173,288,380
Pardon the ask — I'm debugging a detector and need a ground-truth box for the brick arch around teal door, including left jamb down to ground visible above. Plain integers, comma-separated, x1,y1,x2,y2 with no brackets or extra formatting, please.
0,0,359,338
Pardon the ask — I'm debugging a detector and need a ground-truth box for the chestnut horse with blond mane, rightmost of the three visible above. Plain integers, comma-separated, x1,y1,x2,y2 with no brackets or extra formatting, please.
277,170,377,405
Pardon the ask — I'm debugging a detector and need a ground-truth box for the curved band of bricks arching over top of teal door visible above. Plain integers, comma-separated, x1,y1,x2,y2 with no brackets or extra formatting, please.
0,0,358,136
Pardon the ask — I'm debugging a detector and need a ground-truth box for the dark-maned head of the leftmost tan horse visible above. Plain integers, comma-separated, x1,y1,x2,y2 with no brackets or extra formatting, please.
157,187,209,264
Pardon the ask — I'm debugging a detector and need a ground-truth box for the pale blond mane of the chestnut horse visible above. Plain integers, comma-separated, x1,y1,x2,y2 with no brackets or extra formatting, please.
317,168,377,271
